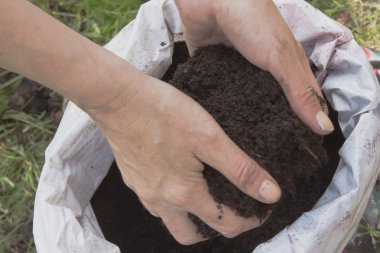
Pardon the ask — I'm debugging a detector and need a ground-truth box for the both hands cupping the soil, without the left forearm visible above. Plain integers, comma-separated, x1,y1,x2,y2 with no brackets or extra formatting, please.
88,0,333,244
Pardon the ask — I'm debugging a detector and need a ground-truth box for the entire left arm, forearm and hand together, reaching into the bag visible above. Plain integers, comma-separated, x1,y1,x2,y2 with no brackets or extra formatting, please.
0,1,281,244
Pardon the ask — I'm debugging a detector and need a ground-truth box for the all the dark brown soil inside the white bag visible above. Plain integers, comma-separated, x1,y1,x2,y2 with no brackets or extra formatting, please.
92,42,343,253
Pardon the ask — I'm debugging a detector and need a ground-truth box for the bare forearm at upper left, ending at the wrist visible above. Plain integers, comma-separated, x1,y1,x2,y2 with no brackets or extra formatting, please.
0,0,138,109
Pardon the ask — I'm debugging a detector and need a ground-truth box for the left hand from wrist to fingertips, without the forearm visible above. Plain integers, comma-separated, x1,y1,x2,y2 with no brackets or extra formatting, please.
89,74,281,244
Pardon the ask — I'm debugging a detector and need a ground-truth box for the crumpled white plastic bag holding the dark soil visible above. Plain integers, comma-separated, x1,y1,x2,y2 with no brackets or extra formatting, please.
33,0,380,253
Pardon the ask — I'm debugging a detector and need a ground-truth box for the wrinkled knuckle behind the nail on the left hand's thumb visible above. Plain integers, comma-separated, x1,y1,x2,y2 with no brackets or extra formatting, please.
233,157,259,189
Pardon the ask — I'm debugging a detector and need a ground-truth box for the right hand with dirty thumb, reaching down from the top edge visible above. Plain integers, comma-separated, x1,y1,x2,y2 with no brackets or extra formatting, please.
176,0,334,134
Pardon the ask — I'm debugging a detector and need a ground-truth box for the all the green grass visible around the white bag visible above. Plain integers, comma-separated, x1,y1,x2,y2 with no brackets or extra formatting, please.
0,0,380,253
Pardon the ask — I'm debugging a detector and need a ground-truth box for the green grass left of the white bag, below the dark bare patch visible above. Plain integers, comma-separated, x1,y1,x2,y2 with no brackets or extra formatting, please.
0,110,54,252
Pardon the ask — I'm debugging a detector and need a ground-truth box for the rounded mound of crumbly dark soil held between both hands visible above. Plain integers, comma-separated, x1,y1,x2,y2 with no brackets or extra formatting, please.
169,46,328,238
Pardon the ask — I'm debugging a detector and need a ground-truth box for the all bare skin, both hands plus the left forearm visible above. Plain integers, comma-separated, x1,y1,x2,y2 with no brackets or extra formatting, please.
0,0,333,244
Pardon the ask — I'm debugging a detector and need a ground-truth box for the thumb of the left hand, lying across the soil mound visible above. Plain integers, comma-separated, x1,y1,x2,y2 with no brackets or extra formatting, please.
195,129,281,204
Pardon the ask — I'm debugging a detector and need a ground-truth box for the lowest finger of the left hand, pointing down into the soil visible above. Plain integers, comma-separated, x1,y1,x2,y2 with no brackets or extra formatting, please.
160,207,207,245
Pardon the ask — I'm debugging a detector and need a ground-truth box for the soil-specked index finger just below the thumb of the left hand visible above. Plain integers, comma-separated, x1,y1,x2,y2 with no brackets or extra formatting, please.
187,181,264,238
